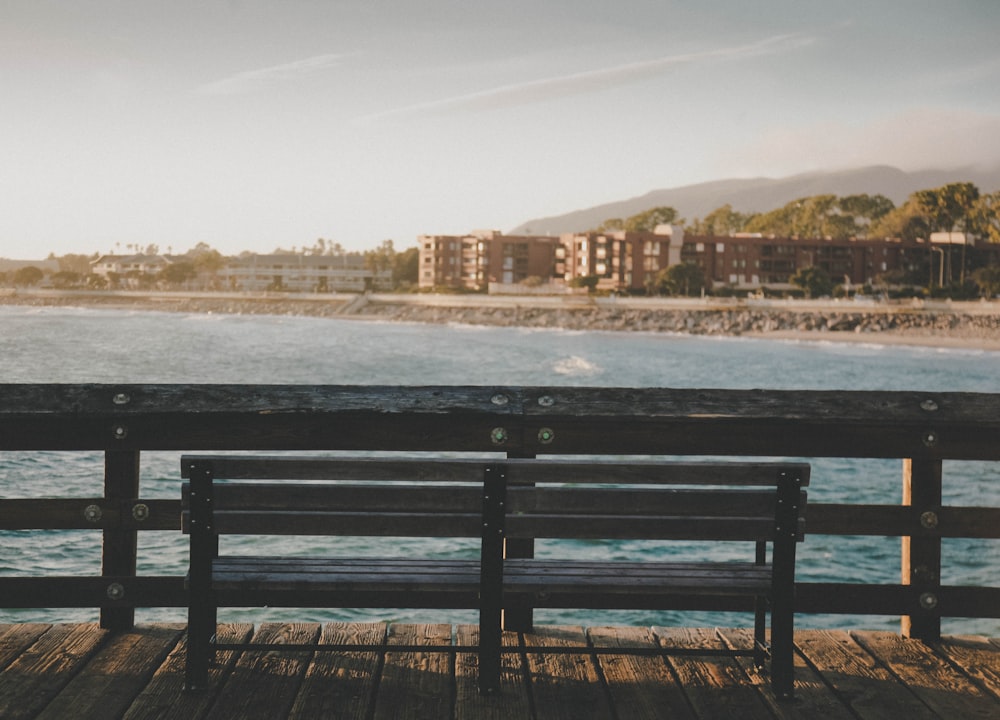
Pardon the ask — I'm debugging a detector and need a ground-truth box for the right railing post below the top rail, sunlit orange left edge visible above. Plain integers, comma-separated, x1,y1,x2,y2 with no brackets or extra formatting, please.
900,458,942,640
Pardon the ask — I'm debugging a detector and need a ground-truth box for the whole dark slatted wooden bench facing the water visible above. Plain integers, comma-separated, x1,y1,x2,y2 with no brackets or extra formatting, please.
181,455,809,697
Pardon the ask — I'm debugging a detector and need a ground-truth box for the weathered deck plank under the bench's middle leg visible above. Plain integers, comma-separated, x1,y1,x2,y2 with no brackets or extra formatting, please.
455,625,531,720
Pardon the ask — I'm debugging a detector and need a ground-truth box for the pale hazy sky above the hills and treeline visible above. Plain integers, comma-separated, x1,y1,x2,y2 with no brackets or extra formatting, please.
0,0,1000,258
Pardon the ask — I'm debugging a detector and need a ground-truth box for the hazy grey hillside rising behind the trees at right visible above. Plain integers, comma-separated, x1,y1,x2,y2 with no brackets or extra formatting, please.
508,165,1000,235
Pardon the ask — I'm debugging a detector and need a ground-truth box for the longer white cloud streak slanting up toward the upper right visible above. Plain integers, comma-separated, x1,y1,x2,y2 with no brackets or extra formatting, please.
358,35,812,121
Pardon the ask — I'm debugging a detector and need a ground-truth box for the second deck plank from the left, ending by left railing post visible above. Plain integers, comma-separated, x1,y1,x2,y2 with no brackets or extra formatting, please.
0,624,109,720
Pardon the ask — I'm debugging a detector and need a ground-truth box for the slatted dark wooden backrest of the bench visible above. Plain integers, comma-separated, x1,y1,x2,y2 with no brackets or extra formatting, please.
182,455,809,541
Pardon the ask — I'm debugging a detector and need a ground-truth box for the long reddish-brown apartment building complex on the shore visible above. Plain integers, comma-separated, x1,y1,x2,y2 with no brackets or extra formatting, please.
420,226,1000,292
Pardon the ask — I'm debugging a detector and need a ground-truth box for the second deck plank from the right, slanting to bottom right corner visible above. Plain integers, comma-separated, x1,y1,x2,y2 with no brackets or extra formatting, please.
851,632,1000,720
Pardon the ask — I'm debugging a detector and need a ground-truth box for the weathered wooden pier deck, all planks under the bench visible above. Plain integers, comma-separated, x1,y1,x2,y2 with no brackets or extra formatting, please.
0,623,1000,720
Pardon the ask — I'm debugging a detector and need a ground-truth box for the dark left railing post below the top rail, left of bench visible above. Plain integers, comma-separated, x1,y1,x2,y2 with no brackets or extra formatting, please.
101,450,139,630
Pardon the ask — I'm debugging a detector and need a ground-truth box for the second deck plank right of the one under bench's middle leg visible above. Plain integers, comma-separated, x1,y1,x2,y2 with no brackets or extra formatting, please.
588,627,695,720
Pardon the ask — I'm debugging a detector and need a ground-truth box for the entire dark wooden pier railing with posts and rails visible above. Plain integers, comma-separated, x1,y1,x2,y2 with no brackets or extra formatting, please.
0,385,1000,639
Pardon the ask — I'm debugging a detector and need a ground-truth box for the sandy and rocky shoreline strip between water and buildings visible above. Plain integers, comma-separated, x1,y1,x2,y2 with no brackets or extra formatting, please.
0,290,1000,352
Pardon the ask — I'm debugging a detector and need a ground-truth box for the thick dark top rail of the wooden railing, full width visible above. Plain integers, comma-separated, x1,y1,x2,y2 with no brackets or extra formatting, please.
0,384,1000,460
